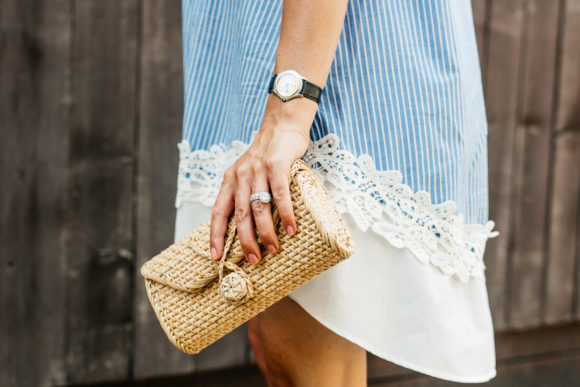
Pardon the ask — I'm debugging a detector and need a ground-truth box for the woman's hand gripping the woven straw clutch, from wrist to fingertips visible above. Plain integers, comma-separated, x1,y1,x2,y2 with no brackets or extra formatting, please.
210,94,318,264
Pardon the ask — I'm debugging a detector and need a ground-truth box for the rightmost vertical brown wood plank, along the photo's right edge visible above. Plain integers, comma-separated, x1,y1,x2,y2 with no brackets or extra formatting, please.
545,0,580,324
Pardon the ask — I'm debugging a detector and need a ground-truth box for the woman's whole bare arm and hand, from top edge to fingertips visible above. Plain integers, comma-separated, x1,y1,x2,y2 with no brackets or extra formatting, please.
210,0,348,264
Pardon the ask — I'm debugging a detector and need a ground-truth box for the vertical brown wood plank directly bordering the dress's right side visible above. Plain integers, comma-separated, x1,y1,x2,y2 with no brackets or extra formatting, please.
485,0,523,330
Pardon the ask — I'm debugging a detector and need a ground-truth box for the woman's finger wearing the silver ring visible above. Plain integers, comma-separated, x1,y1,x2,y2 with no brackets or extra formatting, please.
250,172,278,253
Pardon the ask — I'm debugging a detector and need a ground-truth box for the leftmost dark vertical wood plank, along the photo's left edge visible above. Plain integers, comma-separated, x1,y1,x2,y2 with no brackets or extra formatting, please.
0,0,71,386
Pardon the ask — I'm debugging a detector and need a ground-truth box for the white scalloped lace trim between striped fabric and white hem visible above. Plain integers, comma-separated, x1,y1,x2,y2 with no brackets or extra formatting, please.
175,131,498,283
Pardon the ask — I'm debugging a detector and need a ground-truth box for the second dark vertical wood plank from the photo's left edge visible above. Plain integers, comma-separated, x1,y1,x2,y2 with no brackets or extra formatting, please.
67,0,138,383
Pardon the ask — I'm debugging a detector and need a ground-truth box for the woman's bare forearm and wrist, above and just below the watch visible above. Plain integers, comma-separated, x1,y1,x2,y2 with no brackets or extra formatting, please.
266,0,348,130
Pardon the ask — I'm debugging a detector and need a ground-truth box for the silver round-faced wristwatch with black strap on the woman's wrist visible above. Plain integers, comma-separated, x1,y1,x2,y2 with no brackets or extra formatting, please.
268,70,322,103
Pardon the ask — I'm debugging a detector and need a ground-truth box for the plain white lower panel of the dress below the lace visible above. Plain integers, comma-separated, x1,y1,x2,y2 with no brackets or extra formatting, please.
175,201,496,383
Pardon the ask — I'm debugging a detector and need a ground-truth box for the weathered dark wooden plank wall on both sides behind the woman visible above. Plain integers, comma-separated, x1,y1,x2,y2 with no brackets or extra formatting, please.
0,0,580,386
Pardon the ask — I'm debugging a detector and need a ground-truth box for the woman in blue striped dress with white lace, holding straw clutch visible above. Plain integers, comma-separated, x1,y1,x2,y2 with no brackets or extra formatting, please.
175,0,496,386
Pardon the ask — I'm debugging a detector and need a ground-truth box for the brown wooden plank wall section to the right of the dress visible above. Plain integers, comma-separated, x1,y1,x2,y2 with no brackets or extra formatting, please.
474,0,580,330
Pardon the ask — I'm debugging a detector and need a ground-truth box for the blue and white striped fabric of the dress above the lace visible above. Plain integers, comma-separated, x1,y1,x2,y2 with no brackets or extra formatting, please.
183,0,488,224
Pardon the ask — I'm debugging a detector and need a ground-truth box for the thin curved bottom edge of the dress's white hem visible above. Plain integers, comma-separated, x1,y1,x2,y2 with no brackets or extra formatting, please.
288,294,497,383
